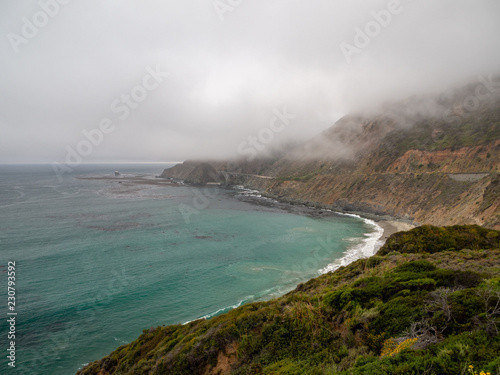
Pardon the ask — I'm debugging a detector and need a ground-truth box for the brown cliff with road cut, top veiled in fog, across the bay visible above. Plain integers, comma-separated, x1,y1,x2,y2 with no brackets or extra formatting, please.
160,91,500,229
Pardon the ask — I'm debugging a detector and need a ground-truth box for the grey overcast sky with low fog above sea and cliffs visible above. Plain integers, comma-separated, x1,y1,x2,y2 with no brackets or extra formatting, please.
0,0,500,163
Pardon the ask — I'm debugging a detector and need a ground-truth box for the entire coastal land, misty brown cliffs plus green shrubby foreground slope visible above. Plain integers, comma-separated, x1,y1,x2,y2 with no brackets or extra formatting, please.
78,85,500,375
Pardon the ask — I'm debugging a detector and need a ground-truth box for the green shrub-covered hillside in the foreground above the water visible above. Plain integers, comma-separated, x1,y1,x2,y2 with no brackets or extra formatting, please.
79,226,500,375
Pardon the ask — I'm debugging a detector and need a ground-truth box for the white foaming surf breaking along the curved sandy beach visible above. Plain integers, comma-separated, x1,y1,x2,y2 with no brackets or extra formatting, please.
319,213,384,274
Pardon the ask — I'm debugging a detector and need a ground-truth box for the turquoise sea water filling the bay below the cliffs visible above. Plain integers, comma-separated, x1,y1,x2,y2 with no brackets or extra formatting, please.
0,164,376,375
